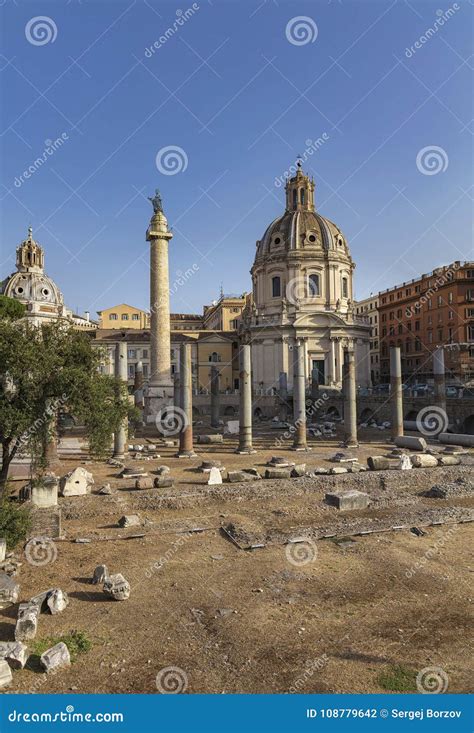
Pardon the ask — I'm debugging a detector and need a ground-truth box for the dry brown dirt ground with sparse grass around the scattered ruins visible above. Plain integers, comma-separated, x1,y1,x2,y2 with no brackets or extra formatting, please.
0,424,474,693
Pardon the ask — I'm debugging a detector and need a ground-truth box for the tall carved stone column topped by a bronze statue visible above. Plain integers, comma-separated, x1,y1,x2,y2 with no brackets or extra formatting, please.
145,190,174,424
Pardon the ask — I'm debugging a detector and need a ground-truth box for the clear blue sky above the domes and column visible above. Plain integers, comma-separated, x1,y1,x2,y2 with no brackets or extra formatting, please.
0,0,474,314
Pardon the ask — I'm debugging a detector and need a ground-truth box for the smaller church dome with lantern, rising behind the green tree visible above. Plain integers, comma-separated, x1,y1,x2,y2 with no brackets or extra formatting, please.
0,227,65,319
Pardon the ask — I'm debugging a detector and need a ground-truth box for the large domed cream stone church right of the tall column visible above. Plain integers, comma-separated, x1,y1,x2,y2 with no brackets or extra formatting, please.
242,165,370,392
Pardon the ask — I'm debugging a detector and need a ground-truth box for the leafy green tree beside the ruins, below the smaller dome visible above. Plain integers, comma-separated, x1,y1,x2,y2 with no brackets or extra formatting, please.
0,320,133,492
